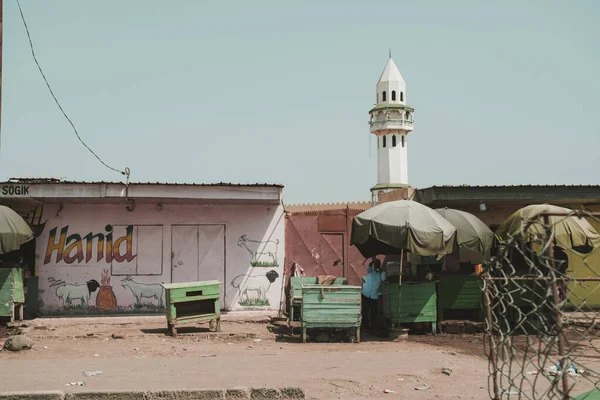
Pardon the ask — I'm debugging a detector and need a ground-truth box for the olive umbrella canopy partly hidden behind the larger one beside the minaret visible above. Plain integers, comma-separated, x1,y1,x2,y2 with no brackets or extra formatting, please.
435,208,494,256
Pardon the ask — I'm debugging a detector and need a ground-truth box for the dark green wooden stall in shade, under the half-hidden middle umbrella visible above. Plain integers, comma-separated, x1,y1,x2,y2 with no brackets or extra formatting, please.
438,275,483,321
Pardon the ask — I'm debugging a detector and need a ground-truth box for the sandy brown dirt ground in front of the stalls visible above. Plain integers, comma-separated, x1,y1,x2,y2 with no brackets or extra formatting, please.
0,314,488,399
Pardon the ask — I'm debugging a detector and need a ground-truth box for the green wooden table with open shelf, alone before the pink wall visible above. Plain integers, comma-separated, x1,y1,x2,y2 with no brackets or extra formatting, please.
163,281,221,336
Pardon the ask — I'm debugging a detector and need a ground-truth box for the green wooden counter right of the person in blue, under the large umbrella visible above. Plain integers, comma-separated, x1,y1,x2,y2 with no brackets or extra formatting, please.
381,282,437,334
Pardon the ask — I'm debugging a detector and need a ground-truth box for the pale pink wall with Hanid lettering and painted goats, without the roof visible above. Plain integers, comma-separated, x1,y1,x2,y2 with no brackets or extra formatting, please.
36,204,285,314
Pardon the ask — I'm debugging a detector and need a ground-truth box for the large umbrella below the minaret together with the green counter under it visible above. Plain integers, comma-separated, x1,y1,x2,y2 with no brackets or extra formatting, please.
351,200,458,332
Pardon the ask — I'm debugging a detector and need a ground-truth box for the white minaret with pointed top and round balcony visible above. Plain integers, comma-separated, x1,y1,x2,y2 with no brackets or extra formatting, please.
369,52,414,200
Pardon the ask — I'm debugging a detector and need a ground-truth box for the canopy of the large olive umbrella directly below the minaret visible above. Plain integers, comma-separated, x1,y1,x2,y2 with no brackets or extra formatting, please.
350,200,457,257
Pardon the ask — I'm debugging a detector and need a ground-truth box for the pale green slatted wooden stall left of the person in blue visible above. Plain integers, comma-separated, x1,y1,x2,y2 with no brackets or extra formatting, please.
301,285,362,343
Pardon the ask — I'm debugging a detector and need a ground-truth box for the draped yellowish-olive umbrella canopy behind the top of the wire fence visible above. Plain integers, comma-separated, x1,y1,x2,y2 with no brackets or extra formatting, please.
496,204,600,249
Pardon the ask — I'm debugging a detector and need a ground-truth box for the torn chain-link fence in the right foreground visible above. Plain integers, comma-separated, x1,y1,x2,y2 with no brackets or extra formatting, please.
482,212,600,400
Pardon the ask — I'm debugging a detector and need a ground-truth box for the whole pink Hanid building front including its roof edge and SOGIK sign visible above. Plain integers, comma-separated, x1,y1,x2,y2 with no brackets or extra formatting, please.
0,181,285,315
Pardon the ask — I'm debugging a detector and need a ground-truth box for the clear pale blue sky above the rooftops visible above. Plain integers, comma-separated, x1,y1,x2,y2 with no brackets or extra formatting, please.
0,0,600,203
